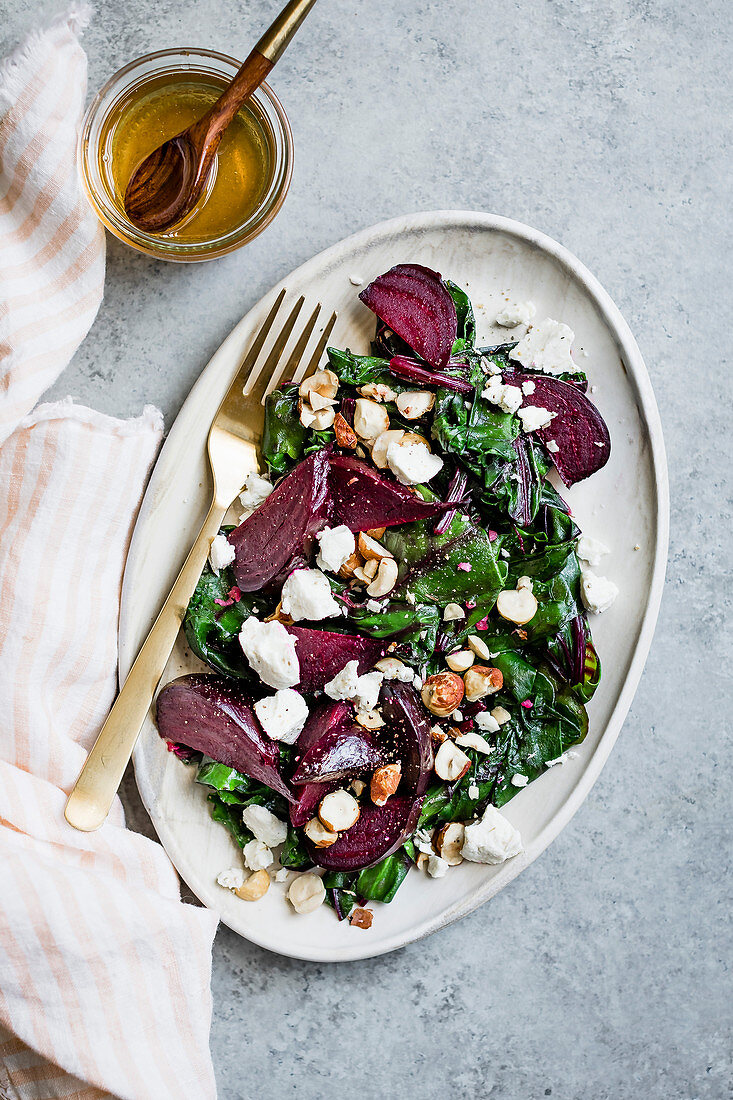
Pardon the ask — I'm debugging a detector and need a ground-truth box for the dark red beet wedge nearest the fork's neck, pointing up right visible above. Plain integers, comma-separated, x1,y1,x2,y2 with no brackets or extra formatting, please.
228,448,331,592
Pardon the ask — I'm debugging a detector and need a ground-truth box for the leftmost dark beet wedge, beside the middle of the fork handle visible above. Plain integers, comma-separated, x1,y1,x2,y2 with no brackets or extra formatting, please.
156,673,294,802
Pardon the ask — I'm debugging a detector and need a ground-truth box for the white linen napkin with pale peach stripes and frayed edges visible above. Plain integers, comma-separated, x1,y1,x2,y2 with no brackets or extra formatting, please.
0,11,217,1100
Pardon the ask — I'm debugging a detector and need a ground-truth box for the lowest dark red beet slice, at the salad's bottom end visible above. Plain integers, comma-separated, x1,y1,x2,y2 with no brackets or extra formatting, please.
308,795,423,871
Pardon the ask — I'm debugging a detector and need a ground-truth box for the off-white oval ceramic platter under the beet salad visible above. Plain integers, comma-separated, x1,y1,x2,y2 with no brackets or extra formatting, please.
120,211,668,961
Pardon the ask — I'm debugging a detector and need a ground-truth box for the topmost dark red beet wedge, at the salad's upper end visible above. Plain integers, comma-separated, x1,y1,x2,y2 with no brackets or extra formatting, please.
359,264,458,370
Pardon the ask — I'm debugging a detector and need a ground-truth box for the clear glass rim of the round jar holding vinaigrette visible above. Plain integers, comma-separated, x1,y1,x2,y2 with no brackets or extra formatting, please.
77,46,293,263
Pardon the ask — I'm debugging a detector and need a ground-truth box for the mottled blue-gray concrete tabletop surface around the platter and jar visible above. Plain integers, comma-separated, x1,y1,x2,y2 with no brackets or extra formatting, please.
0,0,733,1100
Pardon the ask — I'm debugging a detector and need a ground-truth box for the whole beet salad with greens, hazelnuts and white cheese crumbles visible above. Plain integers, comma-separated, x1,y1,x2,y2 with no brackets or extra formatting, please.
156,264,617,928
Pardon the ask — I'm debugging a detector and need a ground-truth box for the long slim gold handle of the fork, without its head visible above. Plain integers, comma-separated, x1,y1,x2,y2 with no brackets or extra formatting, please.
64,499,227,833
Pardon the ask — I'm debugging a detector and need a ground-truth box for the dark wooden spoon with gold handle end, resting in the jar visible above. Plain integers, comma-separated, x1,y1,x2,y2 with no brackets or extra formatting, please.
124,0,316,233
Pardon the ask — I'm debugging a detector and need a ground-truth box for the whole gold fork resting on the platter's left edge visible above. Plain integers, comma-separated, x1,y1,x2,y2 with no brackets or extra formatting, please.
65,289,337,833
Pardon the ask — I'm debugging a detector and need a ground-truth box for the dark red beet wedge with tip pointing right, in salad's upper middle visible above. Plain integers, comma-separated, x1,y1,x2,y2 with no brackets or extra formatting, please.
330,454,447,531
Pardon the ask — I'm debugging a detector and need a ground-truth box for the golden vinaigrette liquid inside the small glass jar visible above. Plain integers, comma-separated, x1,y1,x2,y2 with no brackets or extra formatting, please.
99,74,272,242
